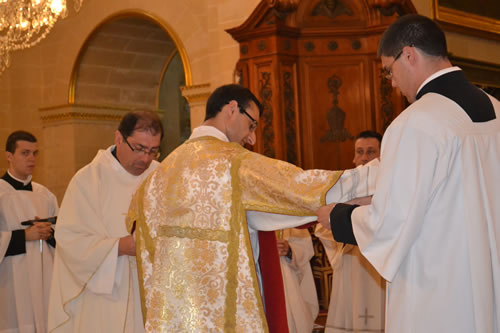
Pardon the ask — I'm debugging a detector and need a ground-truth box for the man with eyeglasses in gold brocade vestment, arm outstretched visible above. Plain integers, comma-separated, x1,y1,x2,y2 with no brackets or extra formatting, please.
127,84,375,333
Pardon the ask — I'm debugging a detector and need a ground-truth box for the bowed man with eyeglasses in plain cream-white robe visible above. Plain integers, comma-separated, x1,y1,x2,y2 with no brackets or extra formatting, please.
49,111,163,333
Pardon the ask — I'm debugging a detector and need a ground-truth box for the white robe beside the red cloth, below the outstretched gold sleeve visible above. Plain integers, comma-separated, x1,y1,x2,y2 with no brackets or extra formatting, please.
280,229,319,333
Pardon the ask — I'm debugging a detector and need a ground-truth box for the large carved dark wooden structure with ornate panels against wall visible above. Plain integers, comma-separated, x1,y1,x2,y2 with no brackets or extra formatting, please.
227,0,415,169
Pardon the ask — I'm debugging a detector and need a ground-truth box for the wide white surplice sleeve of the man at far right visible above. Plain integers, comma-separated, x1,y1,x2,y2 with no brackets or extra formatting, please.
351,122,440,281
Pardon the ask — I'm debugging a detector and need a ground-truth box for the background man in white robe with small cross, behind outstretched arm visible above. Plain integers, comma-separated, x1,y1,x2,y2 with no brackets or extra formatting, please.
315,131,385,333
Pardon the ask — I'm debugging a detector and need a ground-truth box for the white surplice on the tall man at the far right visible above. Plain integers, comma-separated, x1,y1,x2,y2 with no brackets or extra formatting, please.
352,69,500,333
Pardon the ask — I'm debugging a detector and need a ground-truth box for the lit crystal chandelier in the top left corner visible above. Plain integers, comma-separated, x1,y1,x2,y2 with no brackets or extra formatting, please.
0,0,83,74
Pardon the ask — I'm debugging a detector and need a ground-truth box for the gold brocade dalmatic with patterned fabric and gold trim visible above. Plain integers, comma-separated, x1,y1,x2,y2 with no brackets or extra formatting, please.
127,137,341,332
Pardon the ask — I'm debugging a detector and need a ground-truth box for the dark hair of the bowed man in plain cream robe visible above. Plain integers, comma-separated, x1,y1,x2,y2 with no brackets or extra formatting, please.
118,110,163,139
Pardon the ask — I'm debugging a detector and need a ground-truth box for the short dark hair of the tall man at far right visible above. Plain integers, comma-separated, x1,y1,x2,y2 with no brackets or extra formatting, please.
378,14,448,58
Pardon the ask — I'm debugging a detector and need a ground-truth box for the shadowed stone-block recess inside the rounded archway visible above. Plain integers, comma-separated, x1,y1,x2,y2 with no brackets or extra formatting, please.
68,12,191,109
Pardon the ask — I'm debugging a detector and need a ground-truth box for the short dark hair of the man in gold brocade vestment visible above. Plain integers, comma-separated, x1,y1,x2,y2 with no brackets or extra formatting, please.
205,84,262,120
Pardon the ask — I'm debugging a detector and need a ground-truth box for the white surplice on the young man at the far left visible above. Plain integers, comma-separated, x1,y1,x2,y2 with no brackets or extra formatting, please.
0,179,57,333
